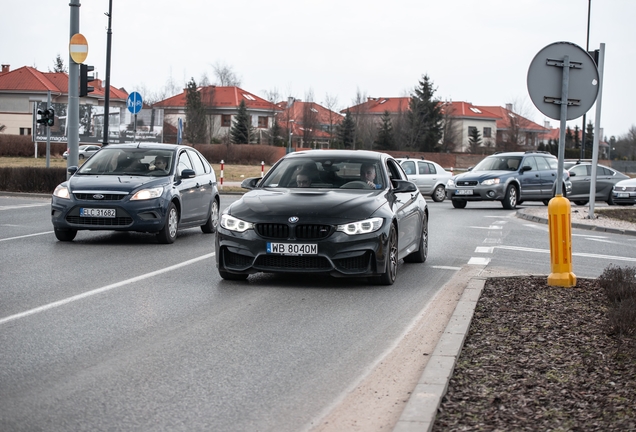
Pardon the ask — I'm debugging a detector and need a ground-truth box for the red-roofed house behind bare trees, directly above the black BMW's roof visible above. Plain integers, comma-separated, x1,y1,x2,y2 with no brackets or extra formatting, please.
276,98,344,149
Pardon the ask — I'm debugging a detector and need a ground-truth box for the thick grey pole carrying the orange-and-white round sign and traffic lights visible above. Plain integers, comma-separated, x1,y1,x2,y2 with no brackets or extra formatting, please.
66,0,80,177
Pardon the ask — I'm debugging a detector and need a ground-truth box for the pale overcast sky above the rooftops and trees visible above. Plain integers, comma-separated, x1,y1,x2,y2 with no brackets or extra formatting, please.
0,0,636,138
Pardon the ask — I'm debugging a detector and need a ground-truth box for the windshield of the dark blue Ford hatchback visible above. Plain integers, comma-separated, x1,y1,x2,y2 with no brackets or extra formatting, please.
77,148,174,177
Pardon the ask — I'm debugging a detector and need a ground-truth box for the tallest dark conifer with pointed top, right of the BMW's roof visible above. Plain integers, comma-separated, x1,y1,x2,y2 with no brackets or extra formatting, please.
408,75,443,152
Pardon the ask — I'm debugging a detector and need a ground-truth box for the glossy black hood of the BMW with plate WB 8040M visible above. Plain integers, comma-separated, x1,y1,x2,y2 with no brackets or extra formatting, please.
227,189,388,224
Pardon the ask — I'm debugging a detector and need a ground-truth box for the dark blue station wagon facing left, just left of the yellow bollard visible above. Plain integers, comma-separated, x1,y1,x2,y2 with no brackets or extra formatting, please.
446,151,572,210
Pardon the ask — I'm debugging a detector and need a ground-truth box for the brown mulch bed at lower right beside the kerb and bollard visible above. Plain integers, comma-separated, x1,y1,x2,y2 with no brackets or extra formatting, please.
433,277,636,431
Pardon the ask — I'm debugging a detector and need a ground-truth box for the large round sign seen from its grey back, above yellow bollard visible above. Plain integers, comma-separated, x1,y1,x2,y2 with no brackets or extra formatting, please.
528,42,599,120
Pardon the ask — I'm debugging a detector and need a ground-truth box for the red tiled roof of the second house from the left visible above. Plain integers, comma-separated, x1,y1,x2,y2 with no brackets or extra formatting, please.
153,86,282,112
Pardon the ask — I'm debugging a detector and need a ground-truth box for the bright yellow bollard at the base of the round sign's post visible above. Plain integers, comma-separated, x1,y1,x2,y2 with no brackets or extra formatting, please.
548,195,576,287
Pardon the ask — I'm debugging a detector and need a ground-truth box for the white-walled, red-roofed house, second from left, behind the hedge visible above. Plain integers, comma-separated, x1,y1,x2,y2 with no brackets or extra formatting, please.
153,85,283,144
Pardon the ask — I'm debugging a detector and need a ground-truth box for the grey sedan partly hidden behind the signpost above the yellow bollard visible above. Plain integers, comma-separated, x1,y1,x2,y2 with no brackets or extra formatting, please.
563,161,629,205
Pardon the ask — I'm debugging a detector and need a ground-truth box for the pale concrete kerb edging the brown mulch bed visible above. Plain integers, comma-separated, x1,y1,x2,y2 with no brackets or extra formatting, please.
393,266,486,432
